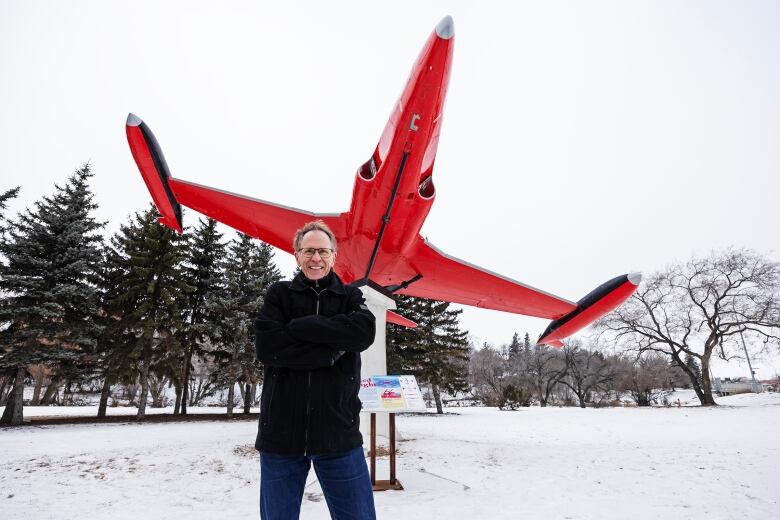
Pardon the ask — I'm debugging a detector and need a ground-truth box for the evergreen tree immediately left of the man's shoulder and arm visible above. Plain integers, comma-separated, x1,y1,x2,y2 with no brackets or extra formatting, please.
207,233,281,416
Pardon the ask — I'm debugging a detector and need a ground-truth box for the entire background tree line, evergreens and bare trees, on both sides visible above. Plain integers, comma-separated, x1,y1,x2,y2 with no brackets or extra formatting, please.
0,164,780,424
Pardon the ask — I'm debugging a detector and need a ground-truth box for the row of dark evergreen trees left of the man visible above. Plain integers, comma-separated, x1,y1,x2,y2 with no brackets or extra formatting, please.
0,164,281,424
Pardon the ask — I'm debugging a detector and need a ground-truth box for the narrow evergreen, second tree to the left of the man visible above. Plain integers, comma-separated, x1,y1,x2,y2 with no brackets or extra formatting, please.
173,219,227,415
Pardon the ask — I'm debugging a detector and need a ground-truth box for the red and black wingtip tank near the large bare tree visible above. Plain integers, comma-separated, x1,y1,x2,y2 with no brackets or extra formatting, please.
537,273,642,348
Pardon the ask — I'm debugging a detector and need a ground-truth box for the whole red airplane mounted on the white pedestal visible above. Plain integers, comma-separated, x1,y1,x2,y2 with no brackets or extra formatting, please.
126,16,641,347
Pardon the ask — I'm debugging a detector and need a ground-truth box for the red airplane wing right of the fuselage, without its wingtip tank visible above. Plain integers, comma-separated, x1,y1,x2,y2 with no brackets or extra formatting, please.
398,236,577,319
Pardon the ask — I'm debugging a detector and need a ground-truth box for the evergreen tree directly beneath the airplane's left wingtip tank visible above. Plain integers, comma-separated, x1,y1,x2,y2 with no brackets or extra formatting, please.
111,207,192,420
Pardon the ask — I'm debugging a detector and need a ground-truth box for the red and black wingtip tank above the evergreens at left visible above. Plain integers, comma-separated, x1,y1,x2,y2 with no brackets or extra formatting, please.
125,113,182,233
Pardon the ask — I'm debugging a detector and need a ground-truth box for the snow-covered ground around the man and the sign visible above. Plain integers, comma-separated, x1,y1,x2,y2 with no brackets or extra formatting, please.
0,394,780,520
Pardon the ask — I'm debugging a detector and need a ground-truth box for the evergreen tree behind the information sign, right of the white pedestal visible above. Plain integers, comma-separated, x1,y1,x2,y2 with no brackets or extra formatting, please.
388,296,469,413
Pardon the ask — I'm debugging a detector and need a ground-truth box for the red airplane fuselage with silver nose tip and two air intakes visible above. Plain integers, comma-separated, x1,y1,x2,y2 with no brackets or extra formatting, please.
339,24,454,285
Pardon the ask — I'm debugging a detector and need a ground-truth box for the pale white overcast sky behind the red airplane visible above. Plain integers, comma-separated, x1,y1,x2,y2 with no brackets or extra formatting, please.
0,0,780,376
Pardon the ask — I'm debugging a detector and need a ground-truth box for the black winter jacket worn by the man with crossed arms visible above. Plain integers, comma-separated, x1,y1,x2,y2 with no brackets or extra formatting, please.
254,272,375,455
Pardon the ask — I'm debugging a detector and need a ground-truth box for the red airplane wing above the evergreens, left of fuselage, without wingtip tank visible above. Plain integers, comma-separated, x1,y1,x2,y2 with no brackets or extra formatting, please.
168,177,344,253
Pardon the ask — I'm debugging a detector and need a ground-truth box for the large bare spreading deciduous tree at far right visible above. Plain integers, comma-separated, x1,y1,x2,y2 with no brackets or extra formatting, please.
599,249,780,406
